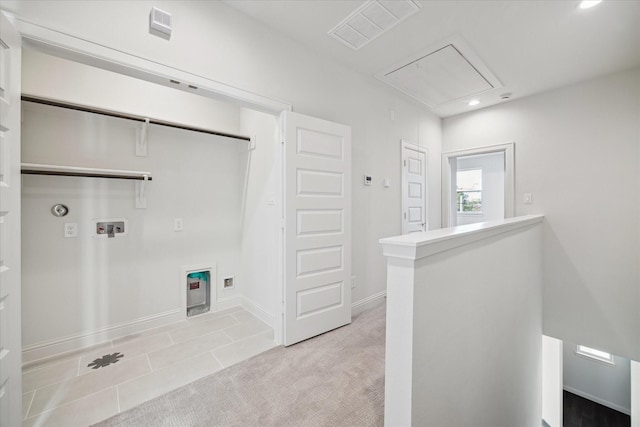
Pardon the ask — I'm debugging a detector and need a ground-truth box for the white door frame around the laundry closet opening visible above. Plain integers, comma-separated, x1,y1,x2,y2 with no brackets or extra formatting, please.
4,12,293,344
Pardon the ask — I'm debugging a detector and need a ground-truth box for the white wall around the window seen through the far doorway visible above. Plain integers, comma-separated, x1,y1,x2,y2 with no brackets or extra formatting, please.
456,152,504,225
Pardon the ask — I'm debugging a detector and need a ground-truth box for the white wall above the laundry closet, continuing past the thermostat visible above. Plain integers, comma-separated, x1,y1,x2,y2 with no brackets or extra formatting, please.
2,1,441,308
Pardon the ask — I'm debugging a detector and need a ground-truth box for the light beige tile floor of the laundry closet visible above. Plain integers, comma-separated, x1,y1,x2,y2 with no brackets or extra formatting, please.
22,307,275,426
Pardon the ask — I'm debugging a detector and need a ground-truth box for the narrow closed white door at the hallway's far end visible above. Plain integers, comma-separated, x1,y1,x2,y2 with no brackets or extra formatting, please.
402,141,427,234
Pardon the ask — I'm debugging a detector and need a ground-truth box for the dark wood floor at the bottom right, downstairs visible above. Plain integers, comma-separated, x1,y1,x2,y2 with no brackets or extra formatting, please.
563,390,631,427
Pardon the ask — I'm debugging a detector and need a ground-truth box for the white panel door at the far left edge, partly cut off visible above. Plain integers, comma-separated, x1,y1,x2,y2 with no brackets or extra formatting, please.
0,13,22,427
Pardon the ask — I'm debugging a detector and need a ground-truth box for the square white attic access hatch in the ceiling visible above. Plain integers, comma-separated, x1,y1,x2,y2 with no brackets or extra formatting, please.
376,37,502,108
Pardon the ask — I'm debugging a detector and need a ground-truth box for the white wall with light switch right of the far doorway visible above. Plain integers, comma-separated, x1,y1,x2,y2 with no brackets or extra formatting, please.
443,69,640,360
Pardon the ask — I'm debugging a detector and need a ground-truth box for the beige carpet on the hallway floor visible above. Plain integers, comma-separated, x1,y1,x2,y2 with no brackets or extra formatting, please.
98,304,385,427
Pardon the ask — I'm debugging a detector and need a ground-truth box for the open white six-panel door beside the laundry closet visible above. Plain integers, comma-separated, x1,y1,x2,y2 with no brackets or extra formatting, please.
281,111,351,345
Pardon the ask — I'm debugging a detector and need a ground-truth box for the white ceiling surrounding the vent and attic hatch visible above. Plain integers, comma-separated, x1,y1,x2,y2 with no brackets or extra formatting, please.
227,0,640,117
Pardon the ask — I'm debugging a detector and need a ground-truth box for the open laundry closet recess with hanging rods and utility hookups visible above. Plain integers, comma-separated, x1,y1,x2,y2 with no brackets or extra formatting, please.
22,48,280,366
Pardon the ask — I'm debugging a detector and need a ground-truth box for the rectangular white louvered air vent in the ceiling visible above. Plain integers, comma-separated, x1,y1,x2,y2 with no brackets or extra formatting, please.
329,0,420,50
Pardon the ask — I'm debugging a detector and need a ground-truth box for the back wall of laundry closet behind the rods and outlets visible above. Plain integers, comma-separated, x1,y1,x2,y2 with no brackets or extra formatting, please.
22,102,247,359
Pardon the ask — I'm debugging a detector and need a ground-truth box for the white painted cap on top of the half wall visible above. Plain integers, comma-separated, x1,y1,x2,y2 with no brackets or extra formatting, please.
380,215,544,260
